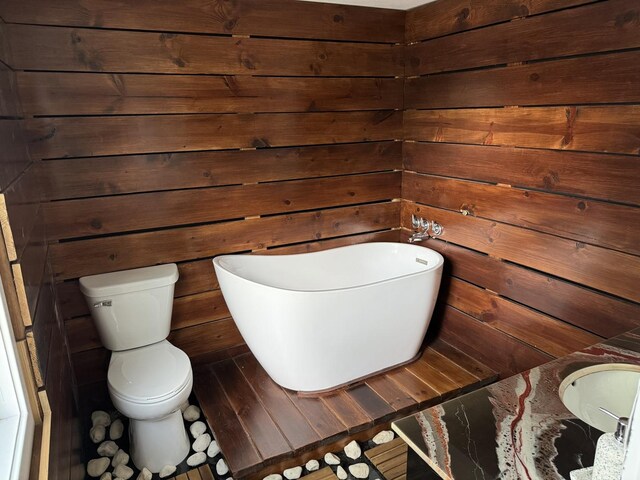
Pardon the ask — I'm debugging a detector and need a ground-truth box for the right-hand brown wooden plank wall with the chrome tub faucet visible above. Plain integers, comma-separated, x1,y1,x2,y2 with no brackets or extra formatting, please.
402,0,640,375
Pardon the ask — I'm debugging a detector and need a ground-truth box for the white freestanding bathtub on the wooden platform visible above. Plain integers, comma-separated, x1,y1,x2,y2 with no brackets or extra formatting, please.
213,243,443,392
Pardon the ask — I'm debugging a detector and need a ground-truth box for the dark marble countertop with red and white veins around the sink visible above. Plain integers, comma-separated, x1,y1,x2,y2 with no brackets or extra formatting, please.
392,329,640,480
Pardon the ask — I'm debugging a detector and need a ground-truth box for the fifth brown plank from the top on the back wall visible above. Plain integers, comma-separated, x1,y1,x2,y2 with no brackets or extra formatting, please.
41,142,402,200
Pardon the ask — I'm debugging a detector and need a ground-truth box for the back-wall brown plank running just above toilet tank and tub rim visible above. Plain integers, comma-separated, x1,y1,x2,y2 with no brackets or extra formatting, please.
51,203,400,280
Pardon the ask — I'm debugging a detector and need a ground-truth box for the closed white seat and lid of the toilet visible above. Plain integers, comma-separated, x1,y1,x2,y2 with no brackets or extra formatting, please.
107,340,192,404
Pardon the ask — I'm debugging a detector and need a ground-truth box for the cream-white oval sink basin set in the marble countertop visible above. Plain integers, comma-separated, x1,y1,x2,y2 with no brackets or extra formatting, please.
559,363,640,432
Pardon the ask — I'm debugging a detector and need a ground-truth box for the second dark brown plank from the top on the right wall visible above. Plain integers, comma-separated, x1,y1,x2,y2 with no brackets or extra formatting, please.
406,0,640,75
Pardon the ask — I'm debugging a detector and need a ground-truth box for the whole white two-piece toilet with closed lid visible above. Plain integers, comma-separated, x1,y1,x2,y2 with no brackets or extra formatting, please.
80,264,193,473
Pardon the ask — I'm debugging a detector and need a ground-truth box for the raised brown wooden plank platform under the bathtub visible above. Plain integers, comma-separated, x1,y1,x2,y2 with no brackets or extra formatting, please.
194,340,496,479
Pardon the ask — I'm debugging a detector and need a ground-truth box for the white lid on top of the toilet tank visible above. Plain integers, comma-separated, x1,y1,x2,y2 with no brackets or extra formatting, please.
80,263,178,297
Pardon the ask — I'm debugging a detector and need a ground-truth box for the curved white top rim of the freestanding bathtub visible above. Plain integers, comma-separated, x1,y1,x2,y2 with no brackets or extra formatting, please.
212,242,444,294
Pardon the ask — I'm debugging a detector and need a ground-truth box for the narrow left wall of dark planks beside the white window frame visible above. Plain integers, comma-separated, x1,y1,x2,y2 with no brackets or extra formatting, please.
0,20,84,480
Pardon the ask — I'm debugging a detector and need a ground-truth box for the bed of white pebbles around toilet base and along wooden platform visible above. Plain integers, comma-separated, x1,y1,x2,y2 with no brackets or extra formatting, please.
86,398,394,480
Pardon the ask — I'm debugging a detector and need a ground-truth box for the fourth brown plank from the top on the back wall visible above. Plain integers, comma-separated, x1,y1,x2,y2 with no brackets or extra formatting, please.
27,110,402,158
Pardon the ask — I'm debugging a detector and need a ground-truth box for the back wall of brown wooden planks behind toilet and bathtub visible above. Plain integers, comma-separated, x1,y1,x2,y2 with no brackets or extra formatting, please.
0,0,404,383
